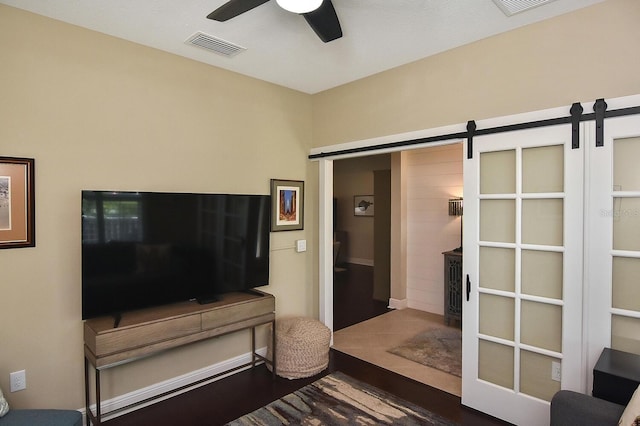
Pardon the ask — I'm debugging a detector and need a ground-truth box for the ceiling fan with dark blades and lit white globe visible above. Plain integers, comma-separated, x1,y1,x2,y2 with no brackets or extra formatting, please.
207,0,342,43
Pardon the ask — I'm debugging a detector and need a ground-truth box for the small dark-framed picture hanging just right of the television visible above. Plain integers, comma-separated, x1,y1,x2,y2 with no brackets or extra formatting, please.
271,179,304,232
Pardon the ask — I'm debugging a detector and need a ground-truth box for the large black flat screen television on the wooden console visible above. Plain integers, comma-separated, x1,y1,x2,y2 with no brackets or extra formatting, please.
82,191,271,319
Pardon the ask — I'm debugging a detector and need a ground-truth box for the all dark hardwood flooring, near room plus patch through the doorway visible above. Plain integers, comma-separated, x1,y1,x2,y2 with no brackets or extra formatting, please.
103,265,505,426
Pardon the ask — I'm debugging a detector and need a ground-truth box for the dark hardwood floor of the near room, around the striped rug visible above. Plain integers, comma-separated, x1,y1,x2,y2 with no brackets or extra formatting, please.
103,350,505,426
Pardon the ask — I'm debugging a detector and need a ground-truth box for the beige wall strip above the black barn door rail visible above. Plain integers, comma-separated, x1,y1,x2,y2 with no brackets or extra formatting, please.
313,0,640,147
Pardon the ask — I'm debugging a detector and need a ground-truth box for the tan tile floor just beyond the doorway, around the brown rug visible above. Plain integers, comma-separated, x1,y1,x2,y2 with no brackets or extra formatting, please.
333,308,462,396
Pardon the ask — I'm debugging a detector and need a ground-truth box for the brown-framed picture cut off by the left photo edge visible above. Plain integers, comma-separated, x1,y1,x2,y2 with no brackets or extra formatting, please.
0,157,36,249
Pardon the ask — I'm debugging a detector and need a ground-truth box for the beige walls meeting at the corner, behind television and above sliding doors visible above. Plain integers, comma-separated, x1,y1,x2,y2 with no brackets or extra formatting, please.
0,0,640,414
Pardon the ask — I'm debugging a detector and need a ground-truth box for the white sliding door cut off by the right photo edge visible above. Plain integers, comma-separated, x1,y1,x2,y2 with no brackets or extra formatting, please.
586,115,640,391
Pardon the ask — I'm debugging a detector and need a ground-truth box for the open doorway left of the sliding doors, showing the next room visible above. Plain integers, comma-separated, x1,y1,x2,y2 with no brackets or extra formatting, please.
332,142,463,395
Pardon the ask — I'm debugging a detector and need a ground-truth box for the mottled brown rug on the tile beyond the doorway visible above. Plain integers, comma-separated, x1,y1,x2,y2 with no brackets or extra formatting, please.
388,328,462,377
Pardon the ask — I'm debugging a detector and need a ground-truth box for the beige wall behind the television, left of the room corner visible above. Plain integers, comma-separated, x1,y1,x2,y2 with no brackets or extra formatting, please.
0,6,318,408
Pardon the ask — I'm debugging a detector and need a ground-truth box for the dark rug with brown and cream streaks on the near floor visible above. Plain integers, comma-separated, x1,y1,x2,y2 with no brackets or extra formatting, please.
227,372,455,426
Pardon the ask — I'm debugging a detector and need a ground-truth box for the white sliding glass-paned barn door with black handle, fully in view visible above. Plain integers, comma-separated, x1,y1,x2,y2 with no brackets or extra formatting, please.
462,125,584,425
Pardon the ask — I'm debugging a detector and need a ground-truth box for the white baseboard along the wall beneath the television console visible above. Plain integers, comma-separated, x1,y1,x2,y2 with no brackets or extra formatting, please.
83,347,267,420
